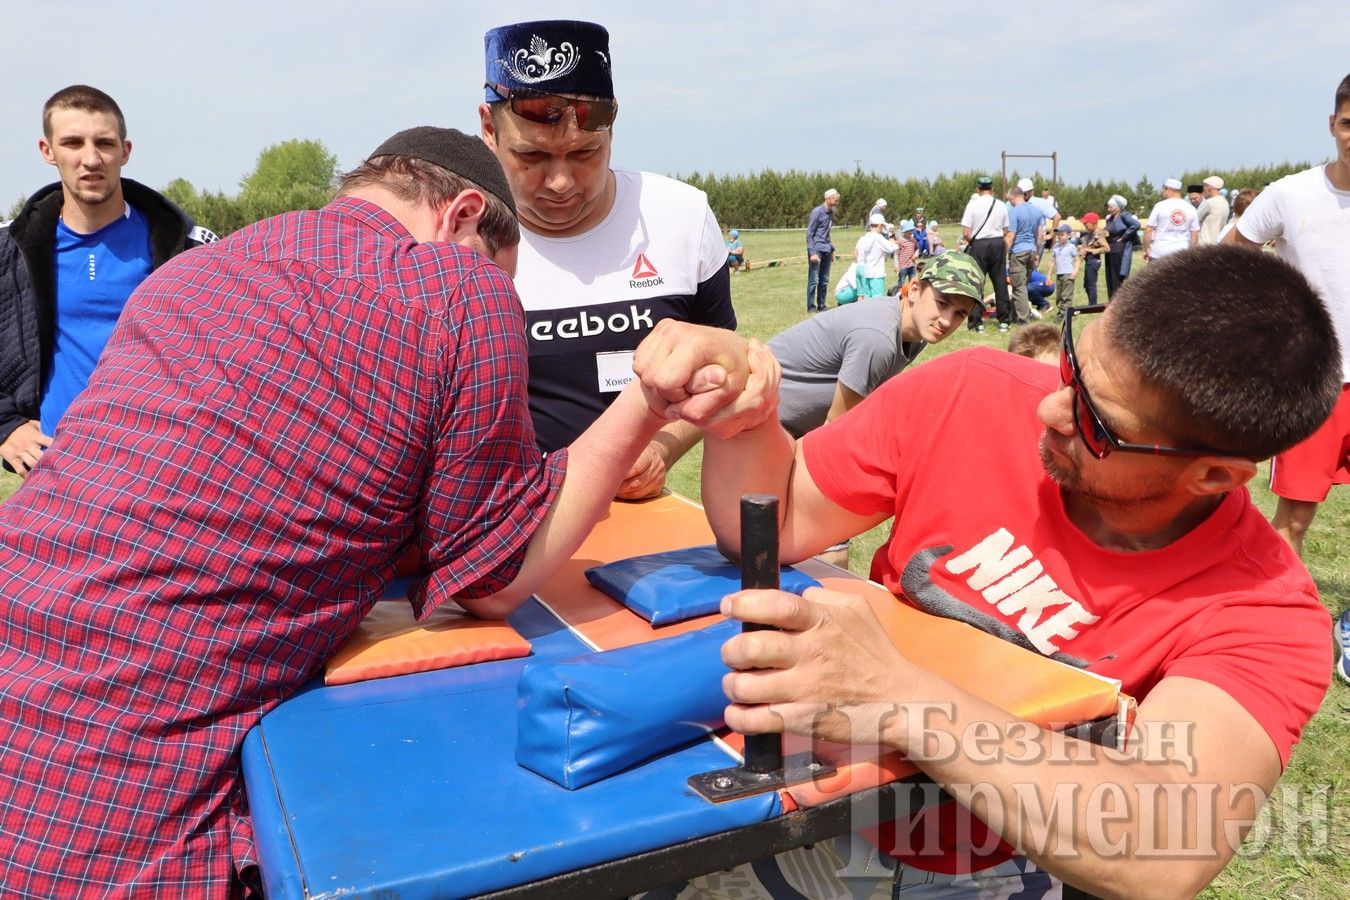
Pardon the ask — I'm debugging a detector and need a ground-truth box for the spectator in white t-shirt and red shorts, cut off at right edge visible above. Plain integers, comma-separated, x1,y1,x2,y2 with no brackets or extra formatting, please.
1227,76,1350,591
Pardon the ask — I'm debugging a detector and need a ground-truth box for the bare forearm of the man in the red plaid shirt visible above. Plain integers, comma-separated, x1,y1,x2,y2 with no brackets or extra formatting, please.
460,382,667,618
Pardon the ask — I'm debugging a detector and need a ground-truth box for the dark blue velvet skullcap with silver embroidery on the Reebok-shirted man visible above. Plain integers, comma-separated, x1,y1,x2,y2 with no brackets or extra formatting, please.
483,19,614,103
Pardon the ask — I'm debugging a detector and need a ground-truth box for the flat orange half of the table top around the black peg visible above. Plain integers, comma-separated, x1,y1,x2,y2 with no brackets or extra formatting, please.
526,495,1129,808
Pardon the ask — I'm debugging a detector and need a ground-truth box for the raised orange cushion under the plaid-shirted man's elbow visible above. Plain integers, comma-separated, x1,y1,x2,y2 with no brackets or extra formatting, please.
324,599,529,684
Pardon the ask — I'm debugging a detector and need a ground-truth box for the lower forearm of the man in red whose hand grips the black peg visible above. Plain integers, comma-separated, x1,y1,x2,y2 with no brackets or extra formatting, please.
887,671,1261,897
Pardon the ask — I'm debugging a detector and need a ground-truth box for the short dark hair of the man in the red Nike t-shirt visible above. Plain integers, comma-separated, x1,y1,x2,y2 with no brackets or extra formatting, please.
1104,244,1342,460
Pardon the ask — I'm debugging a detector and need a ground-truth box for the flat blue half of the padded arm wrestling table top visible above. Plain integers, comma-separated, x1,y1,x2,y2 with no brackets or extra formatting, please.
243,600,782,900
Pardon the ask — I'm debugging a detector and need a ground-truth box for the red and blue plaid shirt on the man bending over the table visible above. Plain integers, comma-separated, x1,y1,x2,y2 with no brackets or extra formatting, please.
0,198,566,897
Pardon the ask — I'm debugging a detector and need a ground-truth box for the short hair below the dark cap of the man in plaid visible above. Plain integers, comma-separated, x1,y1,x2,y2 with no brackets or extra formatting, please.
338,154,520,255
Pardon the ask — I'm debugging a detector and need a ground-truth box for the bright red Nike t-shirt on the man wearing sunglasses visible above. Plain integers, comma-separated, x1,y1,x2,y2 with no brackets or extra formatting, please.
803,349,1330,870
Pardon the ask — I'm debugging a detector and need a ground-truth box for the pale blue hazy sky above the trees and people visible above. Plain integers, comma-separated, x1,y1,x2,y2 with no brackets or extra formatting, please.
0,0,1350,207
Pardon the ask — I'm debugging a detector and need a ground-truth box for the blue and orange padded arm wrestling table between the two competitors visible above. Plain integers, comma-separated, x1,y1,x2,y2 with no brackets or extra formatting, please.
243,495,1127,900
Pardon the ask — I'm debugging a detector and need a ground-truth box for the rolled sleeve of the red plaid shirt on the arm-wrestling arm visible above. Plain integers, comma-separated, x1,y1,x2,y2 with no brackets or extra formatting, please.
412,256,567,617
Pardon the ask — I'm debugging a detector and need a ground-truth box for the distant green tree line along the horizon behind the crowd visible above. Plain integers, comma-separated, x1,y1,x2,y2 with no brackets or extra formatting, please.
7,139,1311,236
